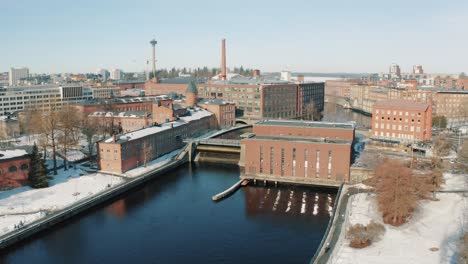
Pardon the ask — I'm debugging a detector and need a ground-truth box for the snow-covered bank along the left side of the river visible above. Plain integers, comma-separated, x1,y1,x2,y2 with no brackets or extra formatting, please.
0,166,123,235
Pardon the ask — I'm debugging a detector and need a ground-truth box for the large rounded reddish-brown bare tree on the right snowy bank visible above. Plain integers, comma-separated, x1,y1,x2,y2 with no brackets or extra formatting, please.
373,159,431,226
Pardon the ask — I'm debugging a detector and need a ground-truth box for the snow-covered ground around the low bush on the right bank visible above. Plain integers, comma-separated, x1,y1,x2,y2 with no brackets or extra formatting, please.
329,174,468,264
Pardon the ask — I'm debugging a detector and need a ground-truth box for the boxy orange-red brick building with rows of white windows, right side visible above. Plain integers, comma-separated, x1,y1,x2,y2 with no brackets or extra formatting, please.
372,100,432,143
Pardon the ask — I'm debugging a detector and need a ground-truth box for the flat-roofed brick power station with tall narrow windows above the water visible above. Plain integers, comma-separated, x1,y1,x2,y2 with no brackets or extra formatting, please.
239,120,355,186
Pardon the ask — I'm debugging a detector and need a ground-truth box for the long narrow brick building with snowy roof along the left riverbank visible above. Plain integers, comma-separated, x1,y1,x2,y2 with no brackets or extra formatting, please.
97,108,216,173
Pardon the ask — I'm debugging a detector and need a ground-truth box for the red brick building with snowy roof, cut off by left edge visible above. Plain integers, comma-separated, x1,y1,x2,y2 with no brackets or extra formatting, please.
0,149,31,189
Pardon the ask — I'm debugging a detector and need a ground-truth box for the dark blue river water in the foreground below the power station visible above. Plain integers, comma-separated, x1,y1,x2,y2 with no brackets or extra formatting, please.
0,164,336,264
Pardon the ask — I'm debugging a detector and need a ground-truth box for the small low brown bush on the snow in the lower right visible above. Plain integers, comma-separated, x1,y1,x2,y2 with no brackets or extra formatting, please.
347,221,385,248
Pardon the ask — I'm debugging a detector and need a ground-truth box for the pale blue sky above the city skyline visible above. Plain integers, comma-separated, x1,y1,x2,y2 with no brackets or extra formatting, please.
0,0,468,73
